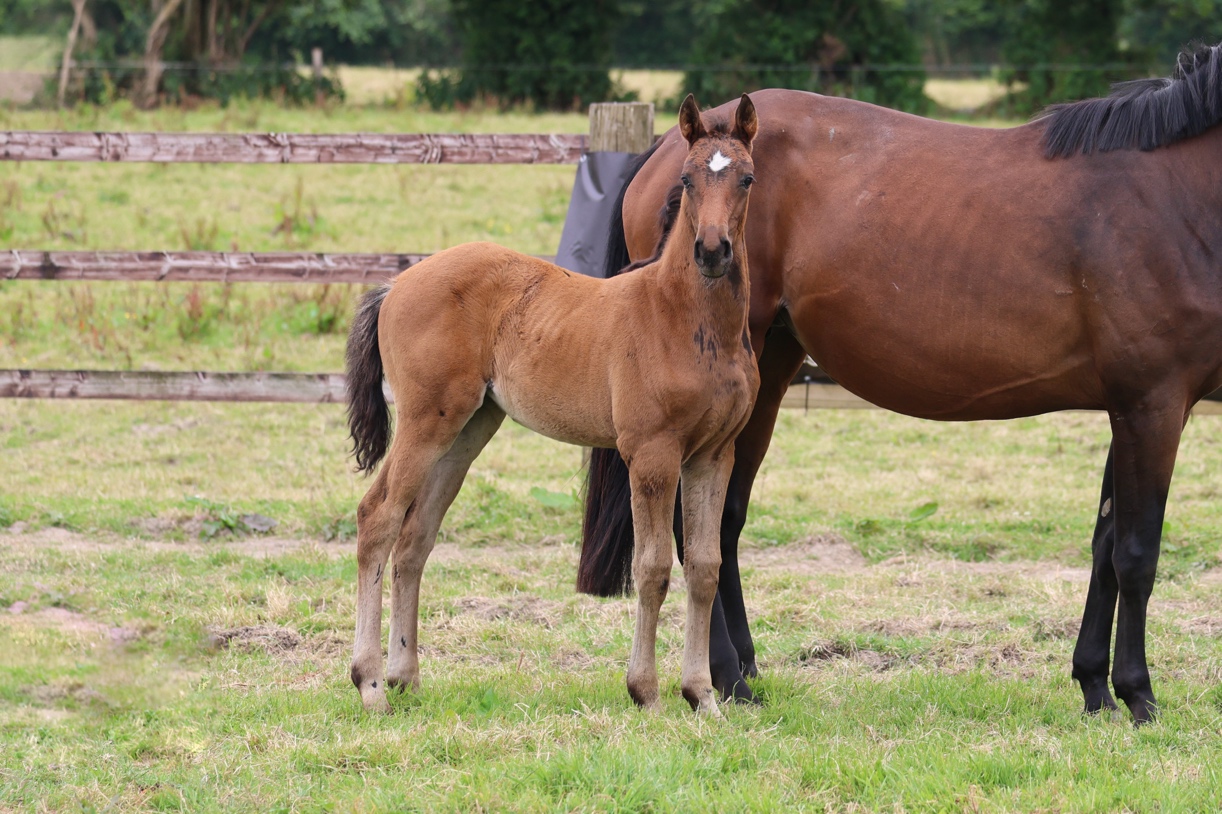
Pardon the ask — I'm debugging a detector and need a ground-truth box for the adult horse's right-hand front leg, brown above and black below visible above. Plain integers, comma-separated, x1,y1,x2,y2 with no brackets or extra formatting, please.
1112,401,1184,724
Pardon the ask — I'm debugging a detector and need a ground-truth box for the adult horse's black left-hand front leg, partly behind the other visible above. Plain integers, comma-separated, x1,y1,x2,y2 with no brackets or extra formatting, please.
1073,445,1118,713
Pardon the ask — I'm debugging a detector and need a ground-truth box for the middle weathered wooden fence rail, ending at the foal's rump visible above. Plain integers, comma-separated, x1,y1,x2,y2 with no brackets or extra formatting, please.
0,249,554,282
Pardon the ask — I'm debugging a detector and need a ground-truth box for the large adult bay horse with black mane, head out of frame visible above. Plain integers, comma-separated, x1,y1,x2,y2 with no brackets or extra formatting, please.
578,46,1222,722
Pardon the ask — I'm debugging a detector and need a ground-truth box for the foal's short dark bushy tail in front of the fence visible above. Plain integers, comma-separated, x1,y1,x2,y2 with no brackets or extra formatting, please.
347,284,390,472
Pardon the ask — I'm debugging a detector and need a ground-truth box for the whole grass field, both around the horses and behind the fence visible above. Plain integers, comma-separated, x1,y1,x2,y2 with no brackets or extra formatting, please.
0,90,1222,812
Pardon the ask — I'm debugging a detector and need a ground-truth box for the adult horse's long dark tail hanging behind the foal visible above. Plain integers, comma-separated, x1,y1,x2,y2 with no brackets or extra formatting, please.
577,141,683,596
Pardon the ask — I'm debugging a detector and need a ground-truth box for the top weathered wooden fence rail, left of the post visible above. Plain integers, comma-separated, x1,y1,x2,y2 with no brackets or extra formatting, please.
0,131,587,164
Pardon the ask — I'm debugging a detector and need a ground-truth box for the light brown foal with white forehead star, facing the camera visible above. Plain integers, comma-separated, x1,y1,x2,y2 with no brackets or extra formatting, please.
347,95,759,714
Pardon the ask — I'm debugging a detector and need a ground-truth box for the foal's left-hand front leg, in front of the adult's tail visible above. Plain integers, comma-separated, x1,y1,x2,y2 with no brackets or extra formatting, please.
621,439,684,708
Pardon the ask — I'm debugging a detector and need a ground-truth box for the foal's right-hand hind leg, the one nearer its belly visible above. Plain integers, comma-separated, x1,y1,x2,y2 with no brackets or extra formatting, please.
386,400,505,689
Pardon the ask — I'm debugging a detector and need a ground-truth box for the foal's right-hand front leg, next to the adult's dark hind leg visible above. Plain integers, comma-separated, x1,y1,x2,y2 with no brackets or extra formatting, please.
682,444,734,715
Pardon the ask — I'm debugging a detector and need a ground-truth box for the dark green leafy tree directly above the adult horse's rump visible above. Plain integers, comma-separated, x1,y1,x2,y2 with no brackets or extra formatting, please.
684,0,925,111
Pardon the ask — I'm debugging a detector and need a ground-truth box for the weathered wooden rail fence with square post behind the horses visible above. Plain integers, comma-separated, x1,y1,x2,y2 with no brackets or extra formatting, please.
0,113,1222,413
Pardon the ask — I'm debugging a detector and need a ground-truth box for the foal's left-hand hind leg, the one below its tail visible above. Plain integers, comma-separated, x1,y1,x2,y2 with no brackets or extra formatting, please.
352,387,483,711
